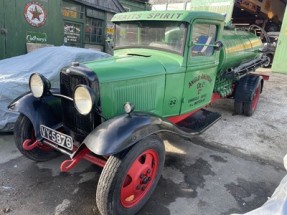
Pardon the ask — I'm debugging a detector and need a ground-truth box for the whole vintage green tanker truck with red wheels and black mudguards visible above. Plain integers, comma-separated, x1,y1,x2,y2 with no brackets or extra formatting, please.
9,11,268,215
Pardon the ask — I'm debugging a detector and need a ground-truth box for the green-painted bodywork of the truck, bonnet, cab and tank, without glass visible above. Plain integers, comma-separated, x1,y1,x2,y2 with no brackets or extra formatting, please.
85,11,262,118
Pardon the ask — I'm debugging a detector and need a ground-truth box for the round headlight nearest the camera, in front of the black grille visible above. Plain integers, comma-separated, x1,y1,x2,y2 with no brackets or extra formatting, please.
74,85,95,115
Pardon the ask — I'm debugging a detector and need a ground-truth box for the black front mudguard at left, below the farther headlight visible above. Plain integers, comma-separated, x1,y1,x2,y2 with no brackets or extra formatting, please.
8,90,62,140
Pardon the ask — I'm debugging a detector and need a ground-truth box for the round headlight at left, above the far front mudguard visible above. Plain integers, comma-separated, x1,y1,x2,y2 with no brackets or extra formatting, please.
29,73,51,98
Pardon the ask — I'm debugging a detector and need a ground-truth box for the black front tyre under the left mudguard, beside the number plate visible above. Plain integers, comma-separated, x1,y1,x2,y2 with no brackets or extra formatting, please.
14,114,61,161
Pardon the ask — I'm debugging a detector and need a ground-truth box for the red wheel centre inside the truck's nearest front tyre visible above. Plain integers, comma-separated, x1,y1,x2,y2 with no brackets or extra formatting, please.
120,149,159,208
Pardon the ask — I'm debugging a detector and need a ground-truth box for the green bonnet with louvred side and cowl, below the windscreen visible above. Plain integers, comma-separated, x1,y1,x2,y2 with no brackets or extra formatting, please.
86,49,185,118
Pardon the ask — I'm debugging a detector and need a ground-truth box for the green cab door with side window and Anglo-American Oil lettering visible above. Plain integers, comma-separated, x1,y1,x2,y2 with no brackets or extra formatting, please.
181,20,220,114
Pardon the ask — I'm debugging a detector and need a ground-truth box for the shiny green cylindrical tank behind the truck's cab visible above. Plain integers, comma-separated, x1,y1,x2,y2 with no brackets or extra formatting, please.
219,30,263,72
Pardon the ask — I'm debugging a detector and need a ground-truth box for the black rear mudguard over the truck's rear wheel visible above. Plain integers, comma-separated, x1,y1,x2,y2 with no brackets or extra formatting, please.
234,74,264,102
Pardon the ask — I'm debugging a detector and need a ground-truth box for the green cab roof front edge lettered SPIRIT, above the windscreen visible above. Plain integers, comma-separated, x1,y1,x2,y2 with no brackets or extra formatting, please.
112,10,224,22
